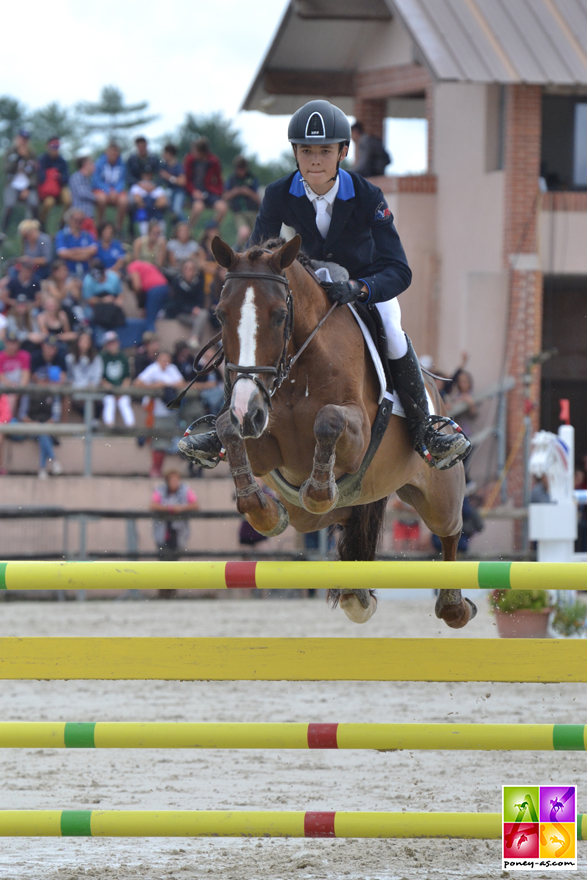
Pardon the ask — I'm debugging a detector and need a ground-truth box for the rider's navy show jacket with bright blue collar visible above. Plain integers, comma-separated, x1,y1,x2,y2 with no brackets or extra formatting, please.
249,168,412,303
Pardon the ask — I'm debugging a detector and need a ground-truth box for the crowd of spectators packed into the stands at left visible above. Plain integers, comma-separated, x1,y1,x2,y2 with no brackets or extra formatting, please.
0,130,261,478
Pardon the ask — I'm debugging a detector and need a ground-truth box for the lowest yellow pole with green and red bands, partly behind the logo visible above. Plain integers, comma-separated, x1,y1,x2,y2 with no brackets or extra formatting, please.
0,810,508,840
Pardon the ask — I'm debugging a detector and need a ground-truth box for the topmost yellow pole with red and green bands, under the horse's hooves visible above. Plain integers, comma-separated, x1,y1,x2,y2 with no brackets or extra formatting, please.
0,561,587,590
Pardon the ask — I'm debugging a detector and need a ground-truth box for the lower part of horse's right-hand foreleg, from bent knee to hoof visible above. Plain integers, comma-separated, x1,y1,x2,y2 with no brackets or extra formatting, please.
299,405,347,515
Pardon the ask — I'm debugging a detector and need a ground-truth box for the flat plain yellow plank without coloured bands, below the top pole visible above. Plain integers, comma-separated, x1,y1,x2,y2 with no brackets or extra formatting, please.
0,640,587,683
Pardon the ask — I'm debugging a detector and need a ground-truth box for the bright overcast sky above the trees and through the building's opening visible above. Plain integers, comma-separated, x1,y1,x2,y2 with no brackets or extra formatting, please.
0,0,425,173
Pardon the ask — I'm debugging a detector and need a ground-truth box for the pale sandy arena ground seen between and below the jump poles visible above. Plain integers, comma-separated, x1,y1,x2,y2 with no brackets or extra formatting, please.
0,592,587,880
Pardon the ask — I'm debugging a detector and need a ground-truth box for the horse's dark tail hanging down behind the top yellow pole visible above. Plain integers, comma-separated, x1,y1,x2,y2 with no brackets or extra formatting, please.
327,497,387,608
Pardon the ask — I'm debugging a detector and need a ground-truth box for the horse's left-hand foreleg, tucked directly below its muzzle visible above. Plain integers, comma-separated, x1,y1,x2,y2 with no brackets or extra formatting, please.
216,412,289,538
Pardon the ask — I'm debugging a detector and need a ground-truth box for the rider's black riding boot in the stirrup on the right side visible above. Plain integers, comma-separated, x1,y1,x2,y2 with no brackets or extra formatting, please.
389,335,471,471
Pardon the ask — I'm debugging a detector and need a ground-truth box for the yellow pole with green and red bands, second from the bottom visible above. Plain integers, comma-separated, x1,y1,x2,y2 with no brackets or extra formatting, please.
0,721,587,751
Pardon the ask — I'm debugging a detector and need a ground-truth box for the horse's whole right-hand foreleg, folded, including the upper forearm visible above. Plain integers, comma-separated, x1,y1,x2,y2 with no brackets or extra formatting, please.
299,404,365,516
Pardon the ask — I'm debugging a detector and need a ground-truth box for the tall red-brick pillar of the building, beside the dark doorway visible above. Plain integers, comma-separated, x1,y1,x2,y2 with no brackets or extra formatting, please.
503,85,542,505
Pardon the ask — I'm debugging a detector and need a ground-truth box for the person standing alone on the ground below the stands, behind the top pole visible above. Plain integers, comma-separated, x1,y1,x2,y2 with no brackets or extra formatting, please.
150,470,200,572
